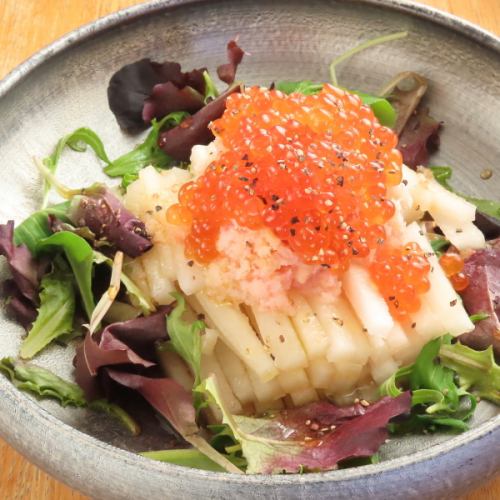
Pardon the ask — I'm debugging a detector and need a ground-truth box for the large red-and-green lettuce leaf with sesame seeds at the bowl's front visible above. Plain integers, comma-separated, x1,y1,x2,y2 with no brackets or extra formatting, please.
204,375,410,474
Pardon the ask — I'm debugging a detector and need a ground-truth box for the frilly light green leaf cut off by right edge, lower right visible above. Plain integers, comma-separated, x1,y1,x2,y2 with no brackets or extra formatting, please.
439,342,500,405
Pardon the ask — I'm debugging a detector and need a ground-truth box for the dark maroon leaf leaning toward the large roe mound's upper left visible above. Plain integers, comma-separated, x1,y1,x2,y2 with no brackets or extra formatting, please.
158,85,240,161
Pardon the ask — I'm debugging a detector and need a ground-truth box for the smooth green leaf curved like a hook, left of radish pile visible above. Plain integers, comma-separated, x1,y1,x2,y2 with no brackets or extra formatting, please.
37,231,95,319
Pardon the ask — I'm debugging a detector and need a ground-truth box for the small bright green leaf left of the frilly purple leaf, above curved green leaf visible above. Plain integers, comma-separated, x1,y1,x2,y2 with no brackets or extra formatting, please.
14,201,70,256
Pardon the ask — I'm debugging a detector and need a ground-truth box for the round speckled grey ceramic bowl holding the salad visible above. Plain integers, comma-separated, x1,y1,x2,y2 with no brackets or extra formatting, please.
0,0,500,499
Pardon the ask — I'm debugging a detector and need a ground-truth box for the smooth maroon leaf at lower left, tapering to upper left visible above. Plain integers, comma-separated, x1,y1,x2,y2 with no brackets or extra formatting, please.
106,369,198,436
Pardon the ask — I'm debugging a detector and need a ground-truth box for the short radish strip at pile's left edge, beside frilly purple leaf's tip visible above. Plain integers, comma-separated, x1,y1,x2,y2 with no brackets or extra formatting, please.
141,244,176,305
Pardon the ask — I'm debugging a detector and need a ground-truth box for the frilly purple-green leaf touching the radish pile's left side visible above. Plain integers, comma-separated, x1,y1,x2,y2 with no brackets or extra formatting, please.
69,187,153,257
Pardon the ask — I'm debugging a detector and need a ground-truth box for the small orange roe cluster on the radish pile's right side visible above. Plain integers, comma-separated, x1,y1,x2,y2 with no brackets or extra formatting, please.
370,242,431,321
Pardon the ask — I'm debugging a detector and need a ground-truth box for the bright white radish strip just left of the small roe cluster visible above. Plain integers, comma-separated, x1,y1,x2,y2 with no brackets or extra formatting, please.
343,264,394,338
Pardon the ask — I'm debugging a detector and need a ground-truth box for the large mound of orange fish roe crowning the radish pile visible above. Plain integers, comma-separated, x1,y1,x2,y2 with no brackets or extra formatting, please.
167,85,402,271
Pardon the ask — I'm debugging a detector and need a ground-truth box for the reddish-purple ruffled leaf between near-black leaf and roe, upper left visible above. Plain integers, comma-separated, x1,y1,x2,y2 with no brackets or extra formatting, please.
142,82,205,123
